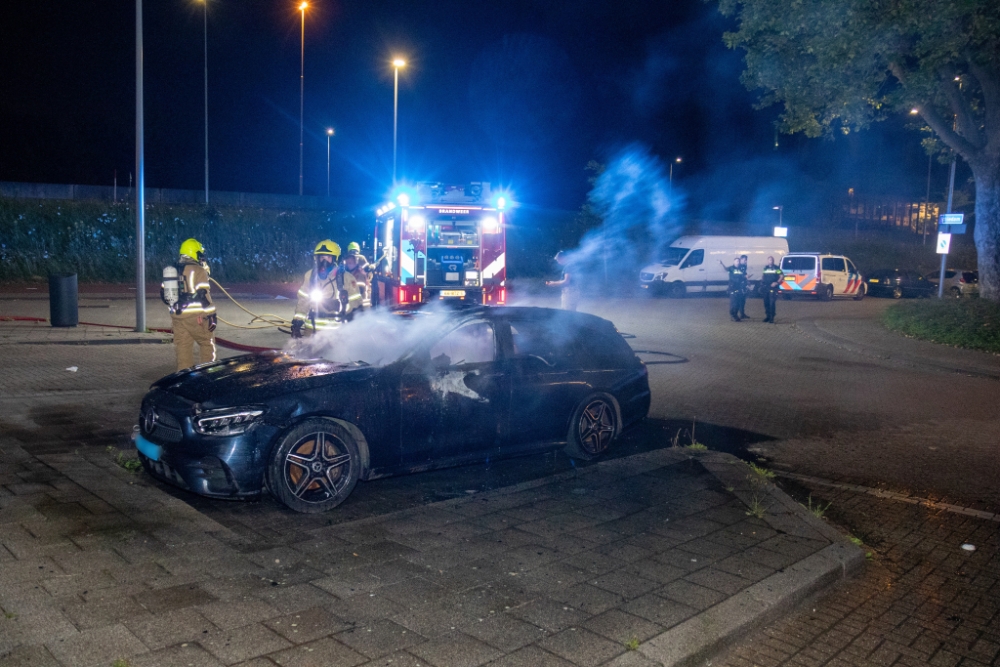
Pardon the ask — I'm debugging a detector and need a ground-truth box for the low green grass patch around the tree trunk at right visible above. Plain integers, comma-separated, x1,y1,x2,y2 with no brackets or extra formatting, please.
882,299,1000,354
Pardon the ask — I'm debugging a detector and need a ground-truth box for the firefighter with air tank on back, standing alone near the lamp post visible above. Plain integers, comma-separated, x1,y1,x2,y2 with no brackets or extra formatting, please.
164,239,217,371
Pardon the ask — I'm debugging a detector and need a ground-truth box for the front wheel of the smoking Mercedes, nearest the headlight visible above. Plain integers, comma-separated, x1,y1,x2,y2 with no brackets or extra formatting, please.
267,419,361,514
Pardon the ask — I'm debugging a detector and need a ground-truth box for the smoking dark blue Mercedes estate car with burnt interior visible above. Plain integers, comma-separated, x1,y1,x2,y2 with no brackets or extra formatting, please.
136,308,650,512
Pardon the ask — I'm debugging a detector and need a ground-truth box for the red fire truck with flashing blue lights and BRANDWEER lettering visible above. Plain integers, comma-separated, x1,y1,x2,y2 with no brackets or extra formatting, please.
375,183,510,305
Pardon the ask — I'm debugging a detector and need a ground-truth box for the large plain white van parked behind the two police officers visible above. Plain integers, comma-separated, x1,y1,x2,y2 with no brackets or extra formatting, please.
639,236,788,297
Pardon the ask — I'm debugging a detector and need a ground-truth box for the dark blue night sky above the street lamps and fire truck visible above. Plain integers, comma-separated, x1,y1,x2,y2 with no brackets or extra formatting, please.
0,0,944,216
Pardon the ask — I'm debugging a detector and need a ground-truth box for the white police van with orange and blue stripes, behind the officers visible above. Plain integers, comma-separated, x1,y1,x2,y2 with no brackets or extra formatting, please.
781,252,867,301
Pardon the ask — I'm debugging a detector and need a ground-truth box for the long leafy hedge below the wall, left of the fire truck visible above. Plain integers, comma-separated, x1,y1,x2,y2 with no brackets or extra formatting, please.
0,198,371,282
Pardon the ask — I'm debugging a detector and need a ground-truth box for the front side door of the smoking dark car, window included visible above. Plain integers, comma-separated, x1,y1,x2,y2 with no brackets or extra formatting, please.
400,320,511,467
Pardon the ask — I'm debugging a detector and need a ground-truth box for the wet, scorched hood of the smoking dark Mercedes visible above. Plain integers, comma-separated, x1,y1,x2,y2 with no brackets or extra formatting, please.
153,353,377,408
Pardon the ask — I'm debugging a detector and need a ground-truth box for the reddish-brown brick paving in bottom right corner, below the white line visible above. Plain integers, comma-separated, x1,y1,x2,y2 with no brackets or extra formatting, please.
712,485,1000,667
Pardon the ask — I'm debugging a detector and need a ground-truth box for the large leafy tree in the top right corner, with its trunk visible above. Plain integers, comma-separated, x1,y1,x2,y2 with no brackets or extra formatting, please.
719,0,1000,301
